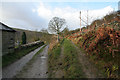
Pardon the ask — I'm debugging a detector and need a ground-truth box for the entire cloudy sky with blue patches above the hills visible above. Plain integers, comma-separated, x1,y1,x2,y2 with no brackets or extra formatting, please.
0,0,119,31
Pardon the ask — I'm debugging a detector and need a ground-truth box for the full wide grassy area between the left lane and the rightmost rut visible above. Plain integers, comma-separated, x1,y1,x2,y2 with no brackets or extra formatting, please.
48,39,85,78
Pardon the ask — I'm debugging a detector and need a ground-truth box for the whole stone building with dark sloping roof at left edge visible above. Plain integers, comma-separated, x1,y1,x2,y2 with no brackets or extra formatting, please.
0,22,16,56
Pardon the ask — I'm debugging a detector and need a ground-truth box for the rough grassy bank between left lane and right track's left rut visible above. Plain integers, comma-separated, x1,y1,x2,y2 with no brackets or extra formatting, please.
48,40,61,78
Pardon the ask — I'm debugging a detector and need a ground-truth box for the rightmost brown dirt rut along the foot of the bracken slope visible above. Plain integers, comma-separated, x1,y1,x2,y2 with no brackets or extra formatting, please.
71,42,103,78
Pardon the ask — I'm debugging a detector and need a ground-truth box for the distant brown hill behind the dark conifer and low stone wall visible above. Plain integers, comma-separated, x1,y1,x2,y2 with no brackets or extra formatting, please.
13,28,52,43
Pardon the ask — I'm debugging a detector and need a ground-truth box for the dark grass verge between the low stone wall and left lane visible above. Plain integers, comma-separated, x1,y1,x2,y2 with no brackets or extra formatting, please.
2,44,43,67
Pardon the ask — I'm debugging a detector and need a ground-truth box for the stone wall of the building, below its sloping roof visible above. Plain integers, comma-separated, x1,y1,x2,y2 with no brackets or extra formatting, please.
2,31,15,56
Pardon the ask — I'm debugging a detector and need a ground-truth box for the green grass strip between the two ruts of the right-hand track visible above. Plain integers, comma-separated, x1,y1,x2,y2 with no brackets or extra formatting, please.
63,39,85,78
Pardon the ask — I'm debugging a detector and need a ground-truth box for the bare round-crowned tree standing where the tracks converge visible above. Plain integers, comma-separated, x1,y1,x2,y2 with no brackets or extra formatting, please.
48,17,66,41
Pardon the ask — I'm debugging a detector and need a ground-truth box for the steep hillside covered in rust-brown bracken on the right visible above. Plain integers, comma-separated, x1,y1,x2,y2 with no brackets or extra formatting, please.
66,12,120,78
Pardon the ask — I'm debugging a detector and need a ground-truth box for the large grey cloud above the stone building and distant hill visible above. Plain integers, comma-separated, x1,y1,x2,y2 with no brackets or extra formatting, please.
2,2,47,30
